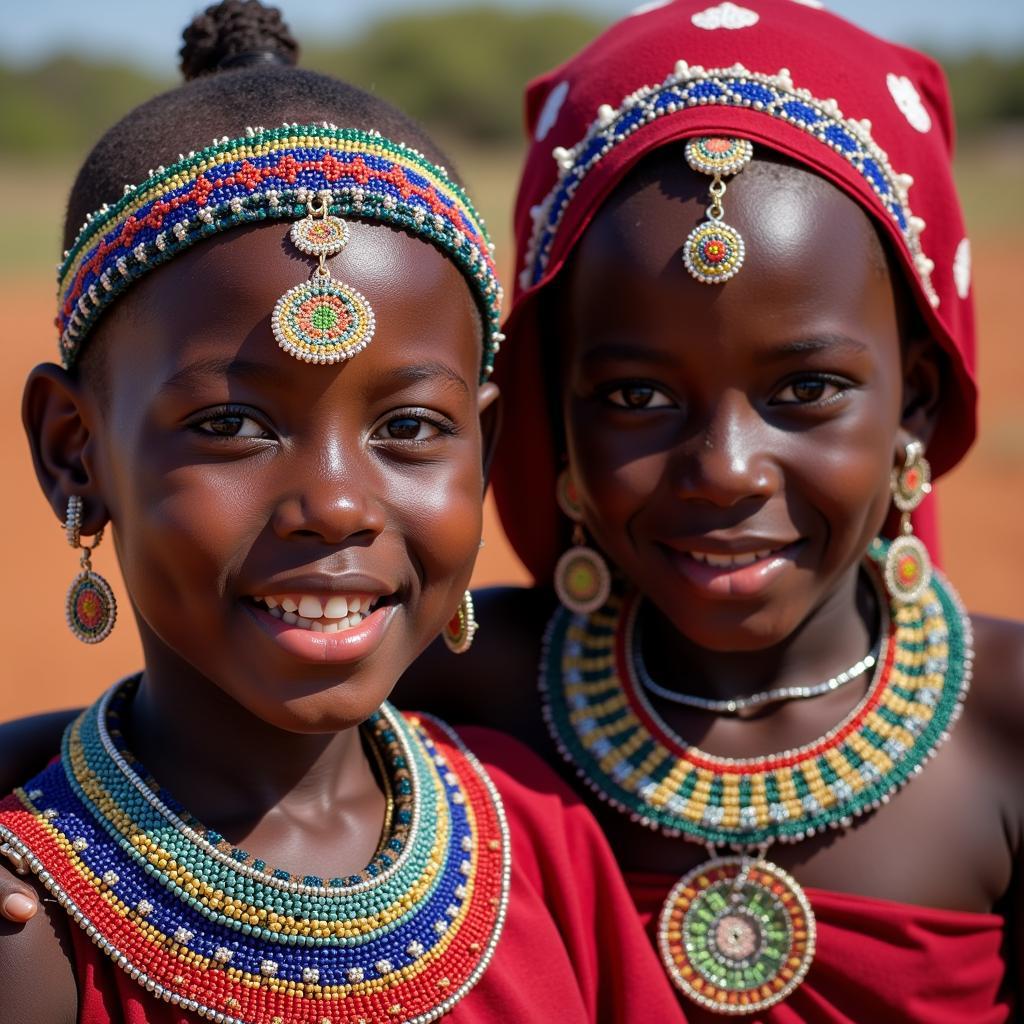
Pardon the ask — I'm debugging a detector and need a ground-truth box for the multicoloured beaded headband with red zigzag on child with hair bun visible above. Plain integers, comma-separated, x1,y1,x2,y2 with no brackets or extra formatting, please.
56,123,503,380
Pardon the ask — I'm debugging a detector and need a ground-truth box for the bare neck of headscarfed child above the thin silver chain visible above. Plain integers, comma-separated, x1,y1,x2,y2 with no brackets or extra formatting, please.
640,568,879,700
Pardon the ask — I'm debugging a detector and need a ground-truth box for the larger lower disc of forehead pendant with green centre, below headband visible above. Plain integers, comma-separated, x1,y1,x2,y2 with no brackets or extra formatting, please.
270,274,377,362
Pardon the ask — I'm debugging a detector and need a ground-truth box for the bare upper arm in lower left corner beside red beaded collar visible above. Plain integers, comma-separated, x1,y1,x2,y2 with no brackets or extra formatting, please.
0,862,78,1024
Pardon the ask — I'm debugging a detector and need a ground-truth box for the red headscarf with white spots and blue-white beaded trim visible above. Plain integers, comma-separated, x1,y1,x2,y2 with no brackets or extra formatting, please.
494,0,976,581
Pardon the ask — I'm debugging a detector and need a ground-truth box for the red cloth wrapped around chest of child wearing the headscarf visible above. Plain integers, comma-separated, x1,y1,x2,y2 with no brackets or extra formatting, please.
627,872,1013,1024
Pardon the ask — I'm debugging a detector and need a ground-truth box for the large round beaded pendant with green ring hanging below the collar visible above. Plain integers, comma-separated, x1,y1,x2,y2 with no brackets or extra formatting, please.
657,857,815,1015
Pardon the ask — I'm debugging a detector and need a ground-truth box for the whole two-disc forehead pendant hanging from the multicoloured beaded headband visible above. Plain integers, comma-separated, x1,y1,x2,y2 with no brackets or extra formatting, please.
270,193,377,364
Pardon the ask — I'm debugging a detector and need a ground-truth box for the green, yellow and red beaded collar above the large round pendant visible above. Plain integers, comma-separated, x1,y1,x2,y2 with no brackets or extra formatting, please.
541,542,973,850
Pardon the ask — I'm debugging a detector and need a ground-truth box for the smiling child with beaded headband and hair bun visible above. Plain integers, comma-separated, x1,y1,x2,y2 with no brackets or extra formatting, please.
0,2,678,1024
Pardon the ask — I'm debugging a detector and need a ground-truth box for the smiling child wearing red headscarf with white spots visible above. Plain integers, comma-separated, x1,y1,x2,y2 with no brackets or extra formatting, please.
0,0,1024,1024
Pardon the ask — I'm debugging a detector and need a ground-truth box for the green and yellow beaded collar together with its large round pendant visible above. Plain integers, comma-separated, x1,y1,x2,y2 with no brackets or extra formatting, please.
541,542,973,1015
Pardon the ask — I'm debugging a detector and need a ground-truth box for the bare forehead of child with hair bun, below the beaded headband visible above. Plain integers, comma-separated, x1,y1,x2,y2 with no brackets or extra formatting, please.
92,221,481,387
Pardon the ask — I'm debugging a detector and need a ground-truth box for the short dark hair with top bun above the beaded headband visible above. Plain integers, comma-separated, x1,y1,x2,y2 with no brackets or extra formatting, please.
63,0,455,247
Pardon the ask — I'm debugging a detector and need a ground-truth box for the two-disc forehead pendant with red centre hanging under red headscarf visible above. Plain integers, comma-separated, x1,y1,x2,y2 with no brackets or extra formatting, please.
683,136,754,285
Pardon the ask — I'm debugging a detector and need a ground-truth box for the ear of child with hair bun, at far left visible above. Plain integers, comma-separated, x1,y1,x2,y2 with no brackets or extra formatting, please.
22,362,110,536
